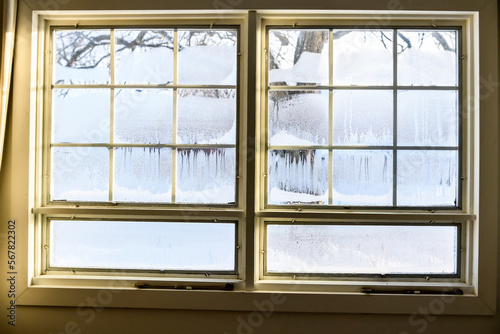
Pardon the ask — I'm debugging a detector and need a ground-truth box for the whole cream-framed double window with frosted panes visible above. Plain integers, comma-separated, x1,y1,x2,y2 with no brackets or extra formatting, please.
26,11,492,312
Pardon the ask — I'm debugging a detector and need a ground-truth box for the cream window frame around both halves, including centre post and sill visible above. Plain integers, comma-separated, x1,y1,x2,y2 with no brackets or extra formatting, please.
18,11,496,315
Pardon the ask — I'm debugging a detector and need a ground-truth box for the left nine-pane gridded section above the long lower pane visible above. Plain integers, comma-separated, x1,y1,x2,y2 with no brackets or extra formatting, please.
48,28,238,205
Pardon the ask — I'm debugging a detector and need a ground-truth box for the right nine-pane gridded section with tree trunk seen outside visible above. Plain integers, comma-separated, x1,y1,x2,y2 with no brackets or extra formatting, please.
265,27,461,208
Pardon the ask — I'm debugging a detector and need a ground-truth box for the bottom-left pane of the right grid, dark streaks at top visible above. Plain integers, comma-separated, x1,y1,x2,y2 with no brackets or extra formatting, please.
267,150,328,204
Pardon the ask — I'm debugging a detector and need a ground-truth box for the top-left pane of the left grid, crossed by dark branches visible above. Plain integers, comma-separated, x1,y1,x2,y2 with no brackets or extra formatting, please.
53,29,110,85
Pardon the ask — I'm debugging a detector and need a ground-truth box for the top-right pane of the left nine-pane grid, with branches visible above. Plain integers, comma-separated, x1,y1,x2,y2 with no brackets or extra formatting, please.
178,29,238,85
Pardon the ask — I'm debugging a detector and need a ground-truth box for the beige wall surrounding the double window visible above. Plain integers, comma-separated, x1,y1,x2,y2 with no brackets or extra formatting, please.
0,0,500,334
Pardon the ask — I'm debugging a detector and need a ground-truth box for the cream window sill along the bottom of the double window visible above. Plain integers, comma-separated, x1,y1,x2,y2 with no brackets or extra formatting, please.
17,285,495,315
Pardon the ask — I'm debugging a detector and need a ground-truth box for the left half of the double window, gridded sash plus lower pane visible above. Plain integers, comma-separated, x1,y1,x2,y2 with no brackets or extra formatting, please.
35,20,246,278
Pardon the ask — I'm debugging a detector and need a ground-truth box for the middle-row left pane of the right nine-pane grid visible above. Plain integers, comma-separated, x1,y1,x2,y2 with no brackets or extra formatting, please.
269,90,328,145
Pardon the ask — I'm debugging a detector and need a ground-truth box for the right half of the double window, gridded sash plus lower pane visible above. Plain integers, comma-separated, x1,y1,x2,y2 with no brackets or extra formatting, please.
262,26,465,279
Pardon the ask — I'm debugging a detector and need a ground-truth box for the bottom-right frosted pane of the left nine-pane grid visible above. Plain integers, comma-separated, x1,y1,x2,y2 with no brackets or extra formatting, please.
175,148,236,204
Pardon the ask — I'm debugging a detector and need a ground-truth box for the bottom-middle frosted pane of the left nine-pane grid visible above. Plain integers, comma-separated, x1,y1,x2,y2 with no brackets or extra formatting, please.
113,147,172,202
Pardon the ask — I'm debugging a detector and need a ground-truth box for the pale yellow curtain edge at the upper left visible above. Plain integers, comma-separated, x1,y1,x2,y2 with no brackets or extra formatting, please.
0,0,17,168
